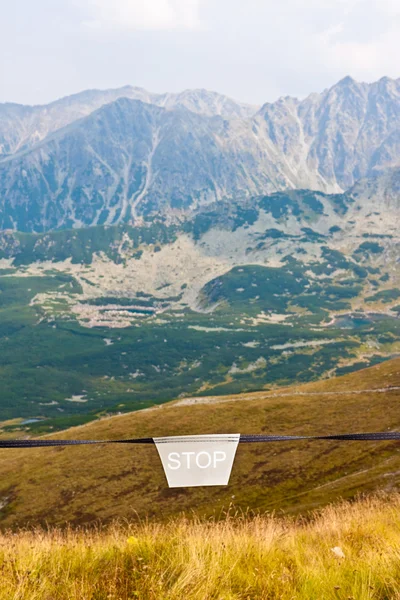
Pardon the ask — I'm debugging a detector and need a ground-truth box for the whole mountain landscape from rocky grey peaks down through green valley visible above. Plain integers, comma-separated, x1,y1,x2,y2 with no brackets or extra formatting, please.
0,77,400,431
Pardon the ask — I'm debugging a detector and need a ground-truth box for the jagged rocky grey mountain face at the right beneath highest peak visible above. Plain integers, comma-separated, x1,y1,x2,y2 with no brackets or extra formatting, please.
256,77,400,191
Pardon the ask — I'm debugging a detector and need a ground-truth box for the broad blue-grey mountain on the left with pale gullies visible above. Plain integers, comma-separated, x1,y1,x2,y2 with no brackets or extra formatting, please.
0,98,275,231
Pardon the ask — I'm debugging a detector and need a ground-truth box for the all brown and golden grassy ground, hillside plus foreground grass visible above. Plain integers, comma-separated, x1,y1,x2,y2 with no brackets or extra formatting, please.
0,359,400,600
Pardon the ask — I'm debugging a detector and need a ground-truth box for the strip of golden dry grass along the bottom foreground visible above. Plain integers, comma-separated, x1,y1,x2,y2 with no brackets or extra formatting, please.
0,494,400,600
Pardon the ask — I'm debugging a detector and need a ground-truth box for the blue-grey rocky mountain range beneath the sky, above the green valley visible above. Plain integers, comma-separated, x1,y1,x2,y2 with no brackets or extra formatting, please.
0,77,400,232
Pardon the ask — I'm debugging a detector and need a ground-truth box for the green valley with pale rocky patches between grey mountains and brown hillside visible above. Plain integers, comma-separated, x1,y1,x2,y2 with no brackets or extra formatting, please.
0,186,400,432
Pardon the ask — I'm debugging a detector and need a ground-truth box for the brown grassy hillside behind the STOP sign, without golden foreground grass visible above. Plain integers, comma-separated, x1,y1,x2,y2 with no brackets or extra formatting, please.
0,359,400,527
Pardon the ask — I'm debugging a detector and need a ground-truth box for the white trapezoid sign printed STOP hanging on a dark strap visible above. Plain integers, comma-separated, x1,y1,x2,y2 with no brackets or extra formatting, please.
153,433,240,487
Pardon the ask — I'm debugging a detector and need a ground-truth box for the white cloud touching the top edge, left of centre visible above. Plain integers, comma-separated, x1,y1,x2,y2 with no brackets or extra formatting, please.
85,0,200,30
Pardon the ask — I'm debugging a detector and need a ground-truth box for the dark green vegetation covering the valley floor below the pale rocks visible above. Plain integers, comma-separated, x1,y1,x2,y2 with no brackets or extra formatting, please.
0,248,400,431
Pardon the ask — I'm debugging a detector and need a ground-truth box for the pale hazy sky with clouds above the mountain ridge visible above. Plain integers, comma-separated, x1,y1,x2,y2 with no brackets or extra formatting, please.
0,0,400,104
